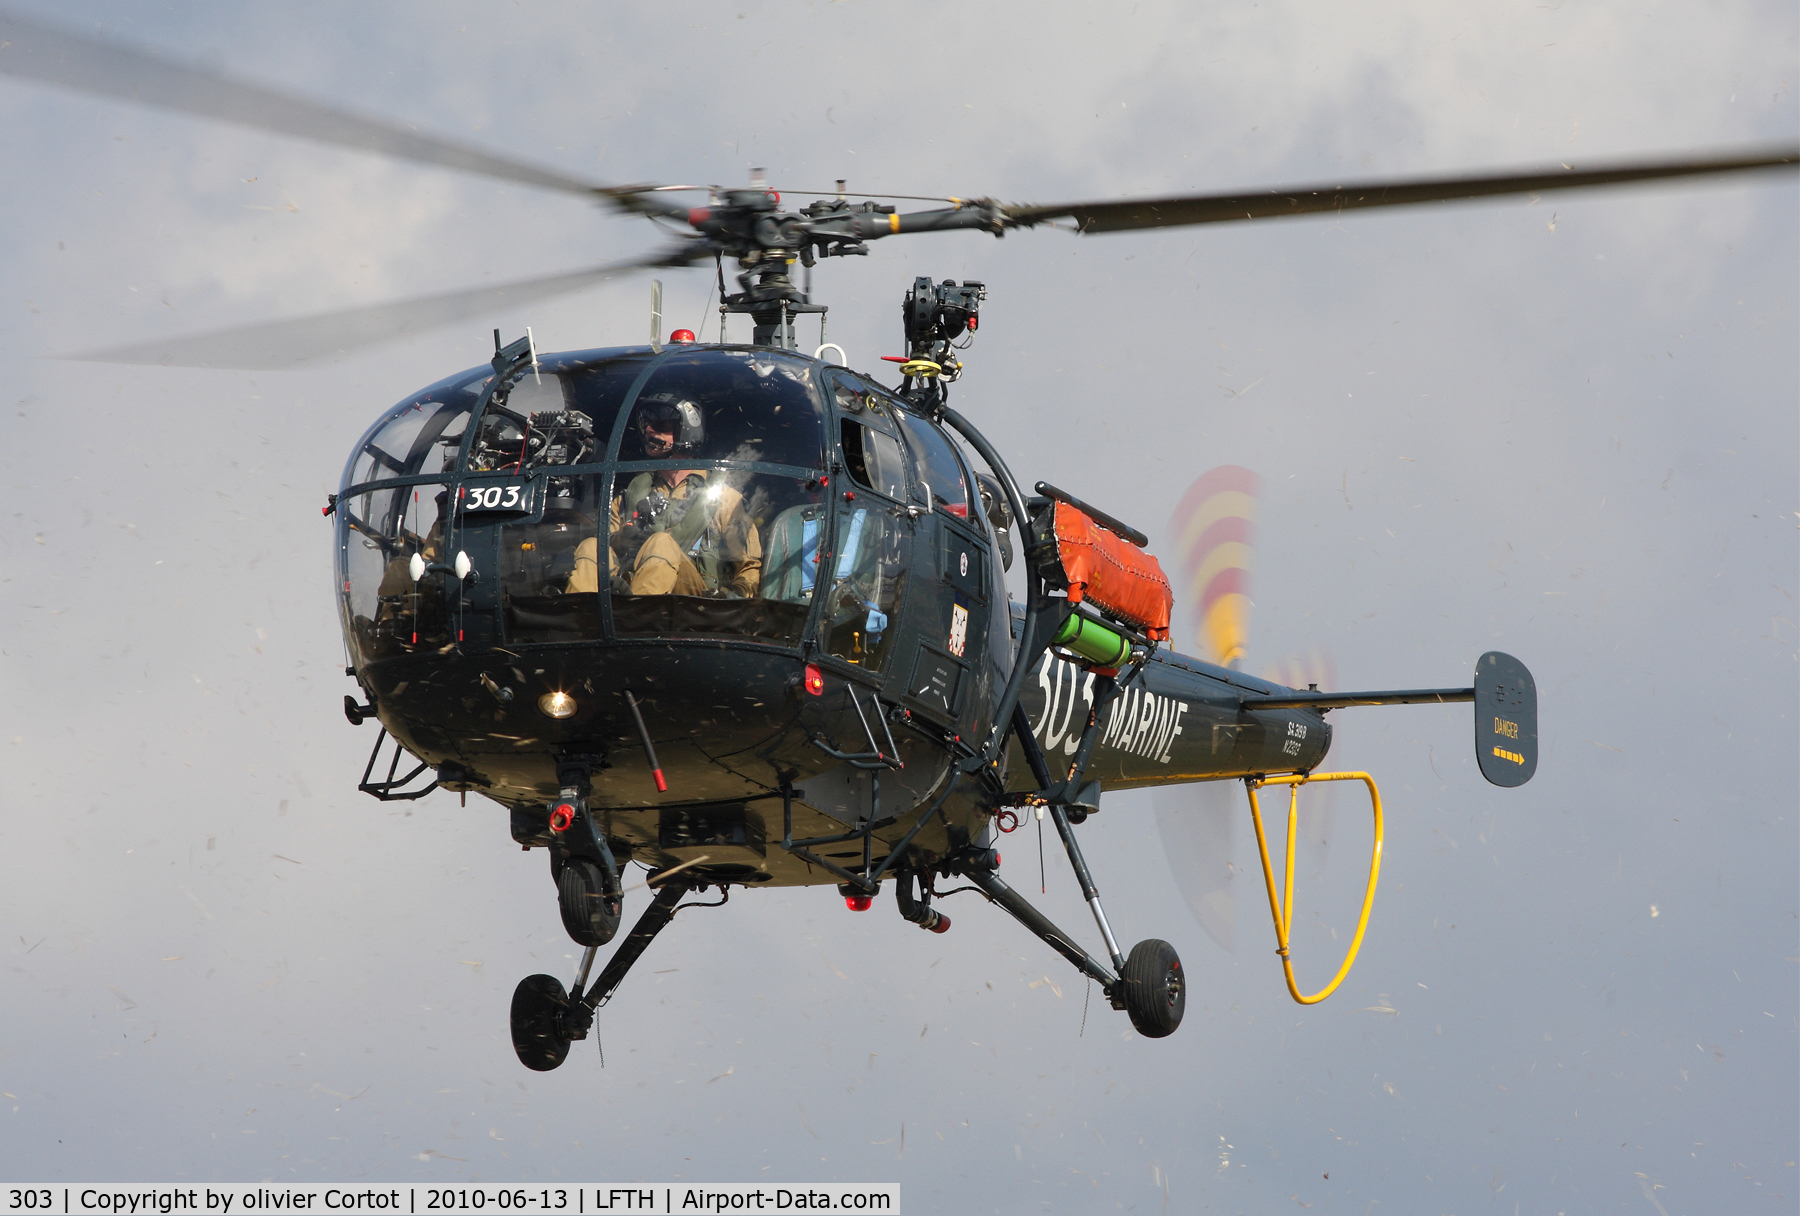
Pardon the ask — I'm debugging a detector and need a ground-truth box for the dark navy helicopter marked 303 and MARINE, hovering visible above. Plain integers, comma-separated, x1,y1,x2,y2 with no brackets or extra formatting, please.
7,7,1796,1070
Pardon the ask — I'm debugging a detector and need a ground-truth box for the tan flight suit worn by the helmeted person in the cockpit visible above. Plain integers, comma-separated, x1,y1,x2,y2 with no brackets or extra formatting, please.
567,471,763,599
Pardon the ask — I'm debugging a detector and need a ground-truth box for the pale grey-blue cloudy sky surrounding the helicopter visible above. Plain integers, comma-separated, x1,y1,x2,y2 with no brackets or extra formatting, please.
0,0,1800,1216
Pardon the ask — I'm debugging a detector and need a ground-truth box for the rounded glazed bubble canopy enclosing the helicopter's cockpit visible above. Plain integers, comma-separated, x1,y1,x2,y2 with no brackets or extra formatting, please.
338,347,983,679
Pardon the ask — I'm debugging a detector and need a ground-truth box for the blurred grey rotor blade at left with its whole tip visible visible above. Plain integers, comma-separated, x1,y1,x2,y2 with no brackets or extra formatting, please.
59,250,693,371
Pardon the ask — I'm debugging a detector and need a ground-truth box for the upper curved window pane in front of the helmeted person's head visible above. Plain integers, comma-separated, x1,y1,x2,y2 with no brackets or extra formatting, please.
619,351,824,469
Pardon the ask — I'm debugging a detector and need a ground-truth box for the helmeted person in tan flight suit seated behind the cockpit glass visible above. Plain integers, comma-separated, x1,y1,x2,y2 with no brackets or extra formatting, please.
567,394,763,599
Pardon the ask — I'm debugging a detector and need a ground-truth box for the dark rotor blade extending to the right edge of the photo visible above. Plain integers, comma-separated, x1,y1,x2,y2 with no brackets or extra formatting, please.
1004,148,1800,232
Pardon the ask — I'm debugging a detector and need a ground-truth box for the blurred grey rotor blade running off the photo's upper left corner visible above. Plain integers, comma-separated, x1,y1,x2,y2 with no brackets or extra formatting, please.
0,11,608,198
